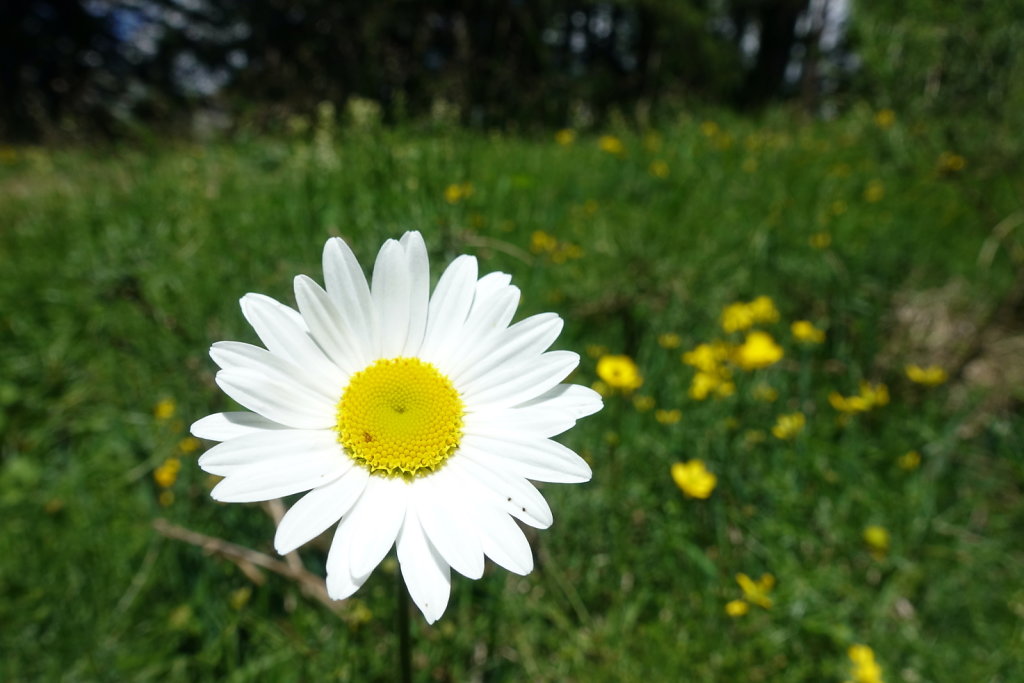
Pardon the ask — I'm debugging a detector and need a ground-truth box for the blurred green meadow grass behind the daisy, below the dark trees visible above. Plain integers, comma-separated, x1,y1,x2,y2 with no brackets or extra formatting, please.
0,112,1024,683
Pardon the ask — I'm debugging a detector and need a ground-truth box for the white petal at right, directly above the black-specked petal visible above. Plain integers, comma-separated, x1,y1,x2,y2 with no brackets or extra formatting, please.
461,435,592,483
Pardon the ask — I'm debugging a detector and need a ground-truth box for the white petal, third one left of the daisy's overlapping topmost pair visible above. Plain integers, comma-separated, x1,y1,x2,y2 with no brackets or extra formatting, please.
242,294,345,385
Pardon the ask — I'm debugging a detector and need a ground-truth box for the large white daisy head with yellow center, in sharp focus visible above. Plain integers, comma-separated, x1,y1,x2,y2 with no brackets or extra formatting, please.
191,232,601,623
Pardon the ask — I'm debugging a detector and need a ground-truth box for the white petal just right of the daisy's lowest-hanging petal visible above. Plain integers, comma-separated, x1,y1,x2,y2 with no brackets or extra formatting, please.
414,468,483,579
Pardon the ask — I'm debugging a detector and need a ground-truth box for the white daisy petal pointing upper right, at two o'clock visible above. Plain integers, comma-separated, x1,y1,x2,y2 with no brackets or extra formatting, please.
451,313,562,388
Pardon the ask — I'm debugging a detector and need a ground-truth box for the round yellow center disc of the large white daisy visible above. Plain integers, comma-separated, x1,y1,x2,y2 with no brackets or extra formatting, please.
336,358,464,476
